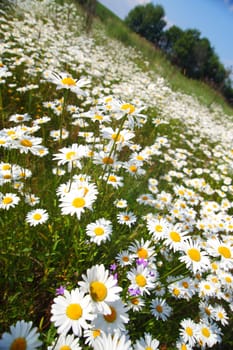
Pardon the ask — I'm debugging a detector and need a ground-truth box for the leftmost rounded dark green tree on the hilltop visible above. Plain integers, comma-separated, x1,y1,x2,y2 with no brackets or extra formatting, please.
125,3,166,45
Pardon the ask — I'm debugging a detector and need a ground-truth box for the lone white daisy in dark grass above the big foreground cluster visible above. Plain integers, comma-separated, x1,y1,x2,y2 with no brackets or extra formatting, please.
86,218,112,245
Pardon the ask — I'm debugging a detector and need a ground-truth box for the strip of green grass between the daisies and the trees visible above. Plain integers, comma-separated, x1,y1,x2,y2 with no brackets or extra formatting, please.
96,3,233,115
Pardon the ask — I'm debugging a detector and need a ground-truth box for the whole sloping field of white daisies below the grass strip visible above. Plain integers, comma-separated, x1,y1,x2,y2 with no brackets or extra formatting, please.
0,0,233,350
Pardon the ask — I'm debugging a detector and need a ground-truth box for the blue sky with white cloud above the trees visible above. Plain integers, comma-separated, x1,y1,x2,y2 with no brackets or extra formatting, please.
99,0,233,69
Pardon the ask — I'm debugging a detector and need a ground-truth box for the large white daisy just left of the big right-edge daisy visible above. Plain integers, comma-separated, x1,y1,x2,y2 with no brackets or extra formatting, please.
179,239,210,273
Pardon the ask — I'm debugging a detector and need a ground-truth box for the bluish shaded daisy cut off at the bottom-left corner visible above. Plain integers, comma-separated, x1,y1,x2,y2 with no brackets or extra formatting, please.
0,320,42,350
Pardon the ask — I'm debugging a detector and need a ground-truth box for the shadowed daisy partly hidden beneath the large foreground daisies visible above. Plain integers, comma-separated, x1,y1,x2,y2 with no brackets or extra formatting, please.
93,300,129,334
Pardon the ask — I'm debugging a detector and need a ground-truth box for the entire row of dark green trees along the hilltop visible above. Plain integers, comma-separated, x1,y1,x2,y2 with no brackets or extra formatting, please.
125,3,233,105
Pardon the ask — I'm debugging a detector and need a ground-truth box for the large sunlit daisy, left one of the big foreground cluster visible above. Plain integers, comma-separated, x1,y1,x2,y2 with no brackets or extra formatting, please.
51,288,95,337
